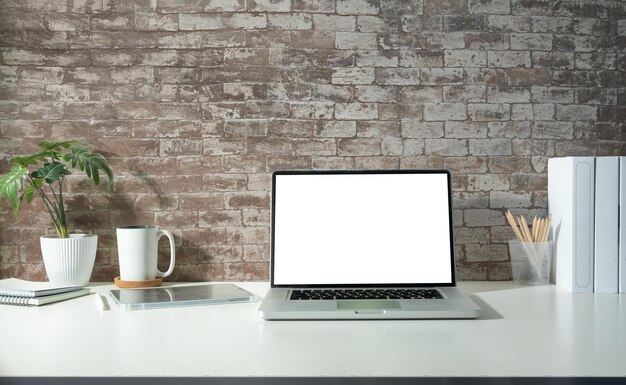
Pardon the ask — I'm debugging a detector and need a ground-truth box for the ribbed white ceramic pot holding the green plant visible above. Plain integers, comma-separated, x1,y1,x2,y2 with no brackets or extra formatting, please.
41,234,98,286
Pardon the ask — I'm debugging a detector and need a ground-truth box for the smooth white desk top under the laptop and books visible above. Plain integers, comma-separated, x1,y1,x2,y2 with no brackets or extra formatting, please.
0,282,626,377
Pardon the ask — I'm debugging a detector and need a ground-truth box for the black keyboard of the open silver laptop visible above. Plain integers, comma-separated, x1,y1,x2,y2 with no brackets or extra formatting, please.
289,289,443,300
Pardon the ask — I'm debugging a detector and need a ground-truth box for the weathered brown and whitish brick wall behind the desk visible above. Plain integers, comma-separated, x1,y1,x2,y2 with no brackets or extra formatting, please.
0,0,626,280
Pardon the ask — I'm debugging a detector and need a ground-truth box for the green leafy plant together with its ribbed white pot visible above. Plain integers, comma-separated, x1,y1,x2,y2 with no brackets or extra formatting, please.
0,139,113,286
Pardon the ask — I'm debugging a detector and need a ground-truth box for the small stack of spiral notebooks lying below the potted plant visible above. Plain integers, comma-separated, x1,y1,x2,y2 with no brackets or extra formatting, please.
0,278,89,306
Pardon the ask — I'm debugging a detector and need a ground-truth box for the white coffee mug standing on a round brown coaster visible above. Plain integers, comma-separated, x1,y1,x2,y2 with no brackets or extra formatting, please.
117,225,176,281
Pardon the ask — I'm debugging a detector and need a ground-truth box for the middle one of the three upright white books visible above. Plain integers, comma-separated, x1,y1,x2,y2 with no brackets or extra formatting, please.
593,156,620,293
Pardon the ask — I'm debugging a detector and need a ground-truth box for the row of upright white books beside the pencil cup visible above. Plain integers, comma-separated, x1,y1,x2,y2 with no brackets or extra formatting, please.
548,156,626,293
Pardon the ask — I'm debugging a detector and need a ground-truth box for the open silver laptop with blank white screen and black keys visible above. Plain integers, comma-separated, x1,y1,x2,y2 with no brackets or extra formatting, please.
259,170,480,320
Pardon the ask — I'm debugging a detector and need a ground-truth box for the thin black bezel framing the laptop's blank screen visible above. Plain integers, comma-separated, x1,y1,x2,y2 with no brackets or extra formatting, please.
270,169,456,288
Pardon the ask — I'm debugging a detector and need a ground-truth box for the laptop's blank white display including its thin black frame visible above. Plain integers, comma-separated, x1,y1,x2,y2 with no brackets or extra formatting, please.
272,171,454,286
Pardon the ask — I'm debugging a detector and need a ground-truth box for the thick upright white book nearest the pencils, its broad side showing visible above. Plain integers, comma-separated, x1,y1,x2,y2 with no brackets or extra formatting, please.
548,157,595,293
